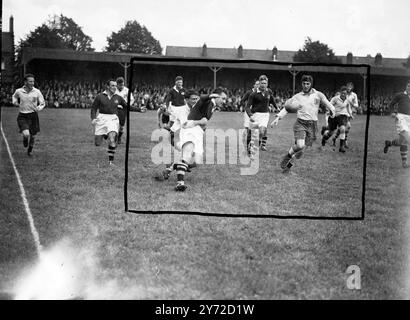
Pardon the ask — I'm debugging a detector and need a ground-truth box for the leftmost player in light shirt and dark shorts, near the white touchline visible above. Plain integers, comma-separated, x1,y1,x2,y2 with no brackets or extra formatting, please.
12,74,46,156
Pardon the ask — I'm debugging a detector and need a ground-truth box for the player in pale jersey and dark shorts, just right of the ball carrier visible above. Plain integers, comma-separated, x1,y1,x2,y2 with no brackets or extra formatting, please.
322,86,352,152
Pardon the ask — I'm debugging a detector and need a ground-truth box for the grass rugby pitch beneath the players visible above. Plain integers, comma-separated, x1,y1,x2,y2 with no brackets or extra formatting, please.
0,108,410,299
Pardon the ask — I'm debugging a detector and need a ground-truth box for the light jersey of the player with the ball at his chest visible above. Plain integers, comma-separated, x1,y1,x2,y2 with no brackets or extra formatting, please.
292,88,334,121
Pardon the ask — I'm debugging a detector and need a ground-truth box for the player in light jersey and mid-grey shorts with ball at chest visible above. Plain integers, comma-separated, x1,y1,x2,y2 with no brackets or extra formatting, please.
271,75,335,172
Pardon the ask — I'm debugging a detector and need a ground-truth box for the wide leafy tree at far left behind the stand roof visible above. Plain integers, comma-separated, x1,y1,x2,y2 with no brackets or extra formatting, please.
17,15,94,53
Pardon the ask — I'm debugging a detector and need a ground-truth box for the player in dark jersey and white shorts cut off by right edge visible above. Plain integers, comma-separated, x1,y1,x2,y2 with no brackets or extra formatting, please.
384,80,410,168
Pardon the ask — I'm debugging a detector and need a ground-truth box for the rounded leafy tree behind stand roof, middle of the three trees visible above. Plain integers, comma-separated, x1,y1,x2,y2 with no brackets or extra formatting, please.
105,20,162,54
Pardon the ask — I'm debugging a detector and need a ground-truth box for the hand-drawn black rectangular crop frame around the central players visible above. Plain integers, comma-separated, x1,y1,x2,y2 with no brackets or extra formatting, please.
124,56,371,221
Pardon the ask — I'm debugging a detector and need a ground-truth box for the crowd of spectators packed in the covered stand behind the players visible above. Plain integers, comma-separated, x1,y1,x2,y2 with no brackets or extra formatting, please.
0,80,400,115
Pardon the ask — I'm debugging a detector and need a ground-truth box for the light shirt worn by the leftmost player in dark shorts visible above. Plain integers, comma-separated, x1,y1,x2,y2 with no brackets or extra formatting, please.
12,86,46,113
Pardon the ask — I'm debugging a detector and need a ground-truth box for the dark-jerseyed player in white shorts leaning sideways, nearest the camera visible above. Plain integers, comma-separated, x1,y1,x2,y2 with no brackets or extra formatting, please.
175,88,227,191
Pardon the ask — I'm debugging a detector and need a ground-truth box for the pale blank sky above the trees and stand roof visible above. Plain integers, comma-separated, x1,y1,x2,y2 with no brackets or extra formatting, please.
3,0,410,58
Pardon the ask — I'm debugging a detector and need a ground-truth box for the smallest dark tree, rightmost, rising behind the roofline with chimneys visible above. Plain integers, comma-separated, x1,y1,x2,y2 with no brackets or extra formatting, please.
293,37,342,63
